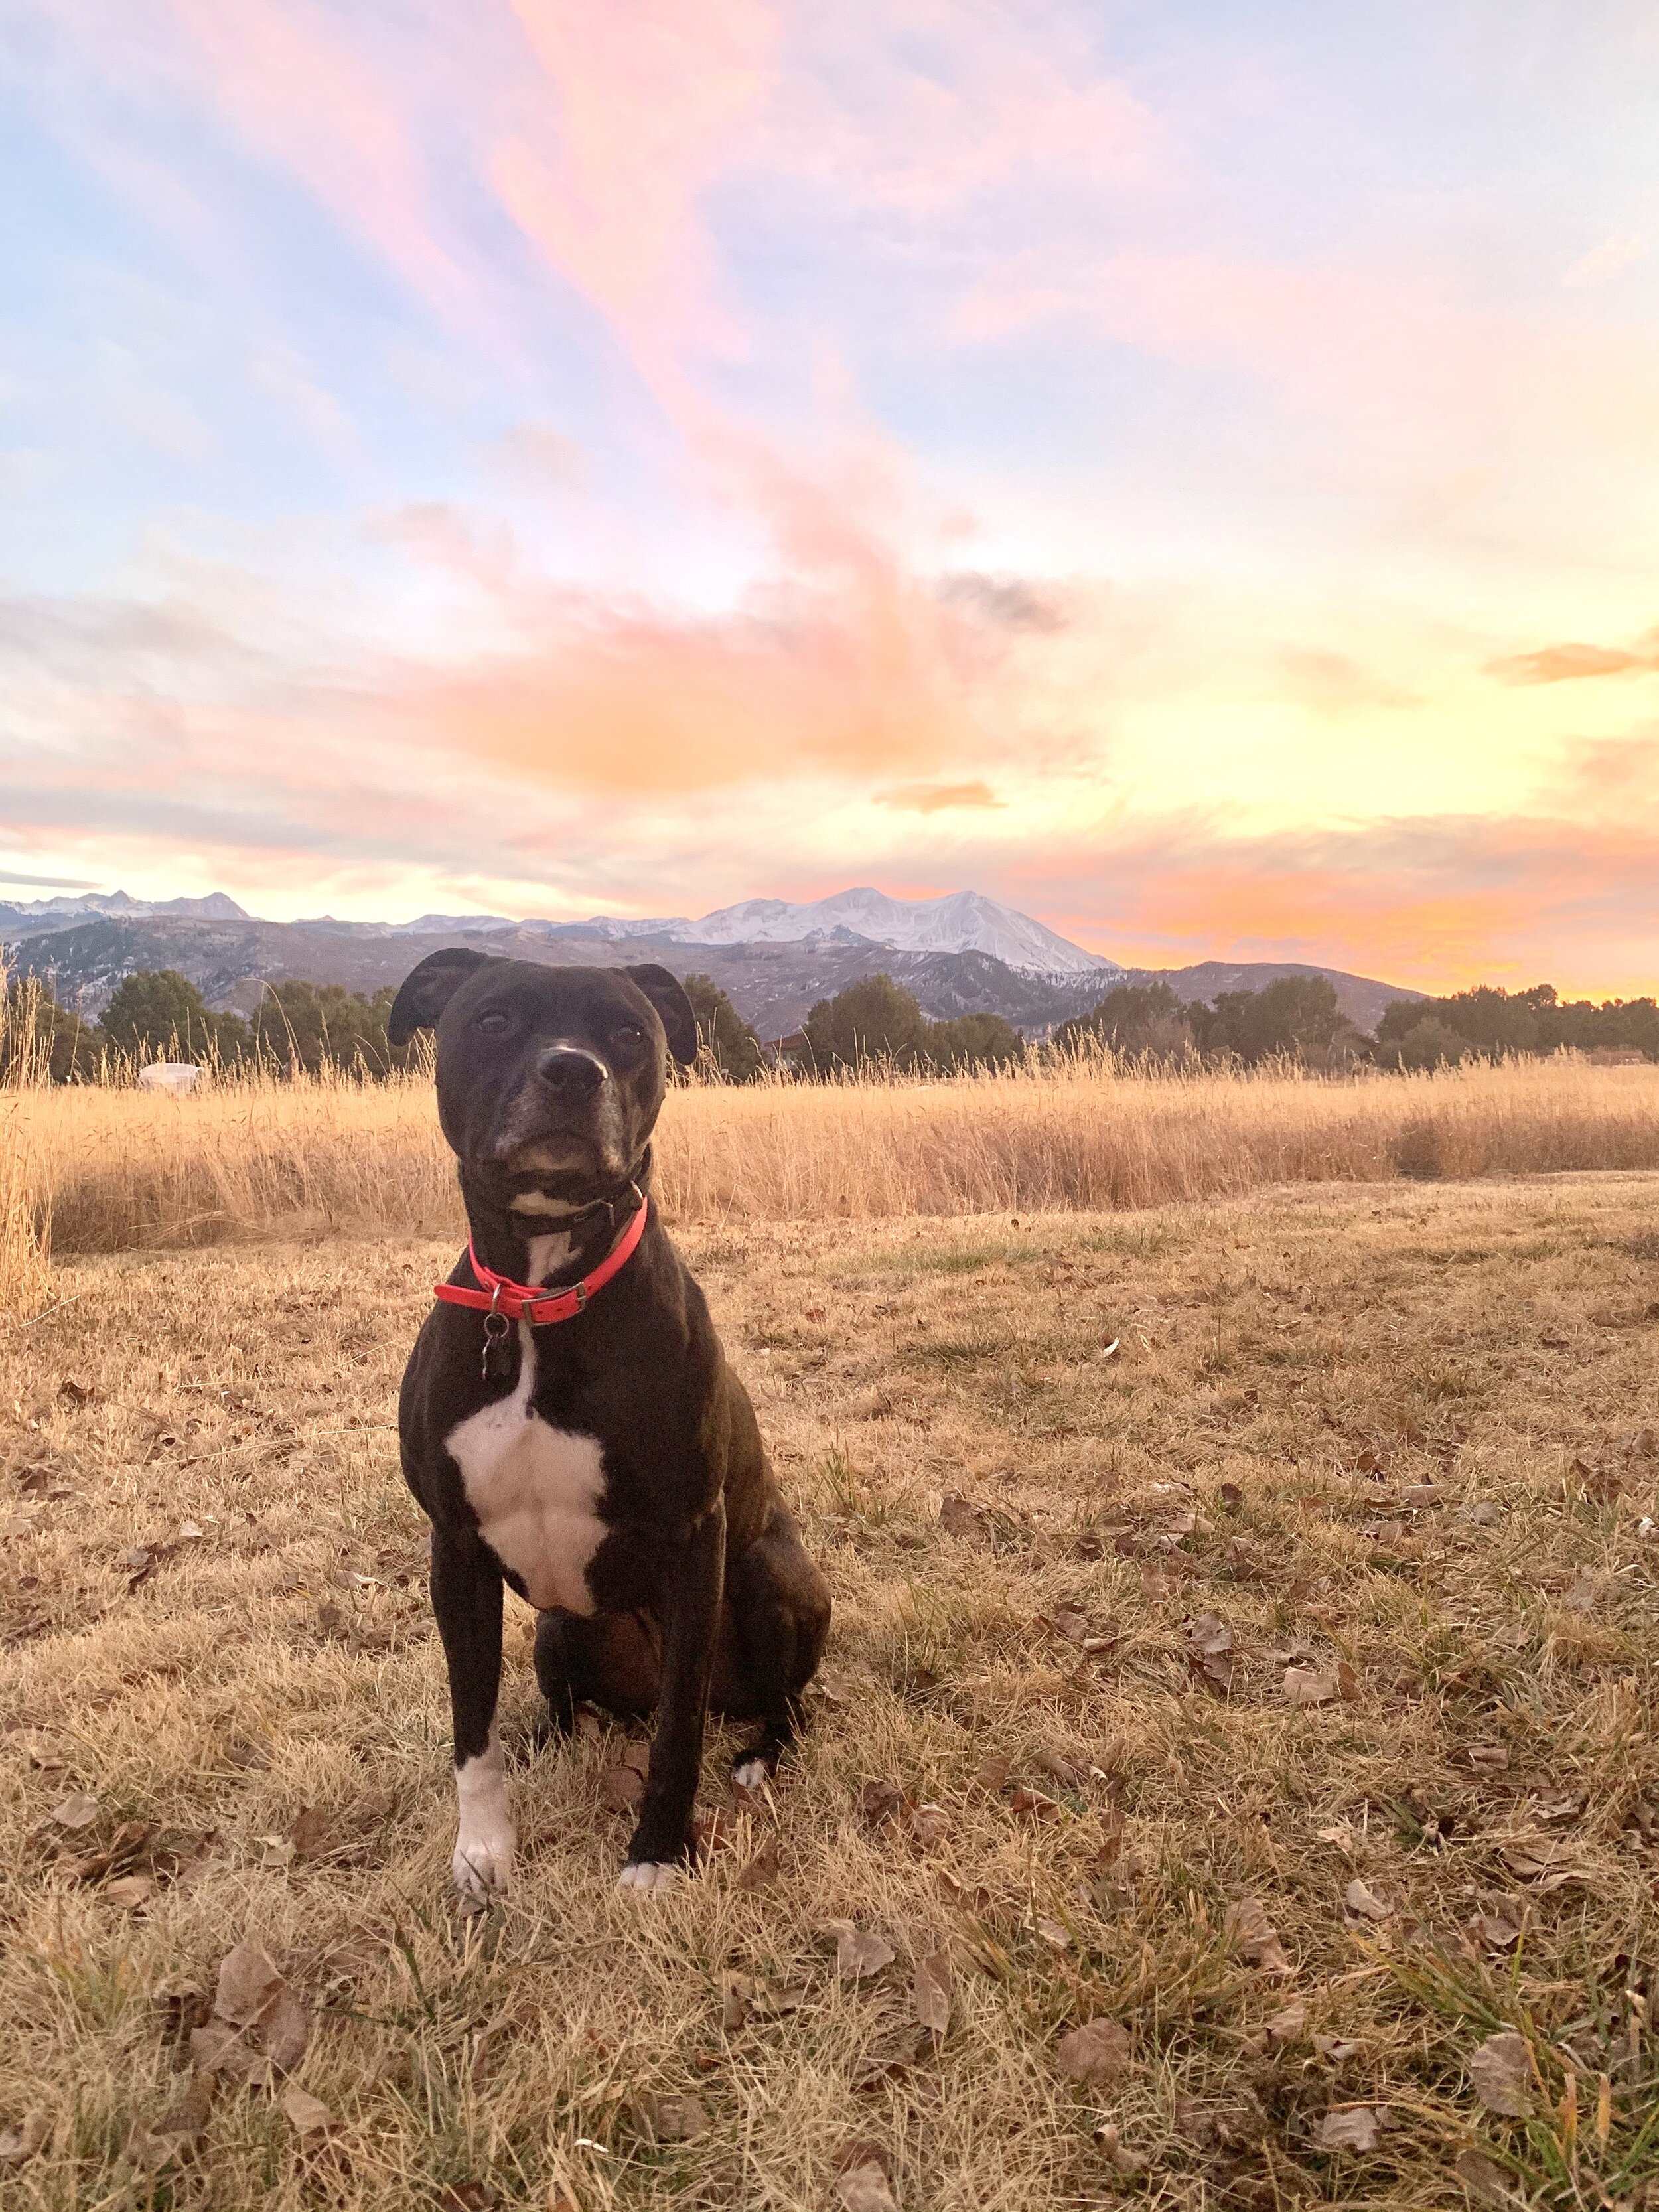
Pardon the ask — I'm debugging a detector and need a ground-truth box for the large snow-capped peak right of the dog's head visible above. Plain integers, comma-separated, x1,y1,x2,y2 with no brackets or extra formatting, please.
553,885,1121,976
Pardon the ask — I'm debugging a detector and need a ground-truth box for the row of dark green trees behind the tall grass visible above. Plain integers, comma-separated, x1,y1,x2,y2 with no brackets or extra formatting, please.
0,969,1659,1084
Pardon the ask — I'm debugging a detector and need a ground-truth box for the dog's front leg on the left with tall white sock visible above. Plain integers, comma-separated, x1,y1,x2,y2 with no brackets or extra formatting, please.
431,1528,513,1895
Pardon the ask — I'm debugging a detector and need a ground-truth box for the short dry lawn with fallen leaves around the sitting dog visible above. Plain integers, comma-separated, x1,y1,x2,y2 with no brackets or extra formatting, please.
0,1167,1659,2212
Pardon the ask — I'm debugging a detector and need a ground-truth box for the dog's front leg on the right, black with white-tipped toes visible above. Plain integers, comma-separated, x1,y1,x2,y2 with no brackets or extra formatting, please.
622,1500,725,1889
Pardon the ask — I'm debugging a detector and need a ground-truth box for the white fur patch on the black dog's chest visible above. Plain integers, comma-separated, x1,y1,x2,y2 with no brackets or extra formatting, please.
445,1321,604,1613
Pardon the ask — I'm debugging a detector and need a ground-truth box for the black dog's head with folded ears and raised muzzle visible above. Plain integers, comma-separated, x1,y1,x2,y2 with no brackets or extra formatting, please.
387,947,697,1212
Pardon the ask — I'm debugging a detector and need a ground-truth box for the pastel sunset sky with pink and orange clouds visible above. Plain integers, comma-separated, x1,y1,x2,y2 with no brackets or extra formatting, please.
0,0,1659,997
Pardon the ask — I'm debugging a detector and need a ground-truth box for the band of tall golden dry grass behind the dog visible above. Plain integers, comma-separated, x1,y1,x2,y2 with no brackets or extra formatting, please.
7,1060,1659,1252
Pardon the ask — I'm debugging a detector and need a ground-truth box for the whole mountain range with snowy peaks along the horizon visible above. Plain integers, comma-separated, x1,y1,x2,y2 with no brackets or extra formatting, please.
0,887,1420,1037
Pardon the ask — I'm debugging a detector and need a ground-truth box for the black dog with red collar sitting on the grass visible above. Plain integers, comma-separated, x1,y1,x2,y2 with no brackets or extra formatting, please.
387,949,830,1891
